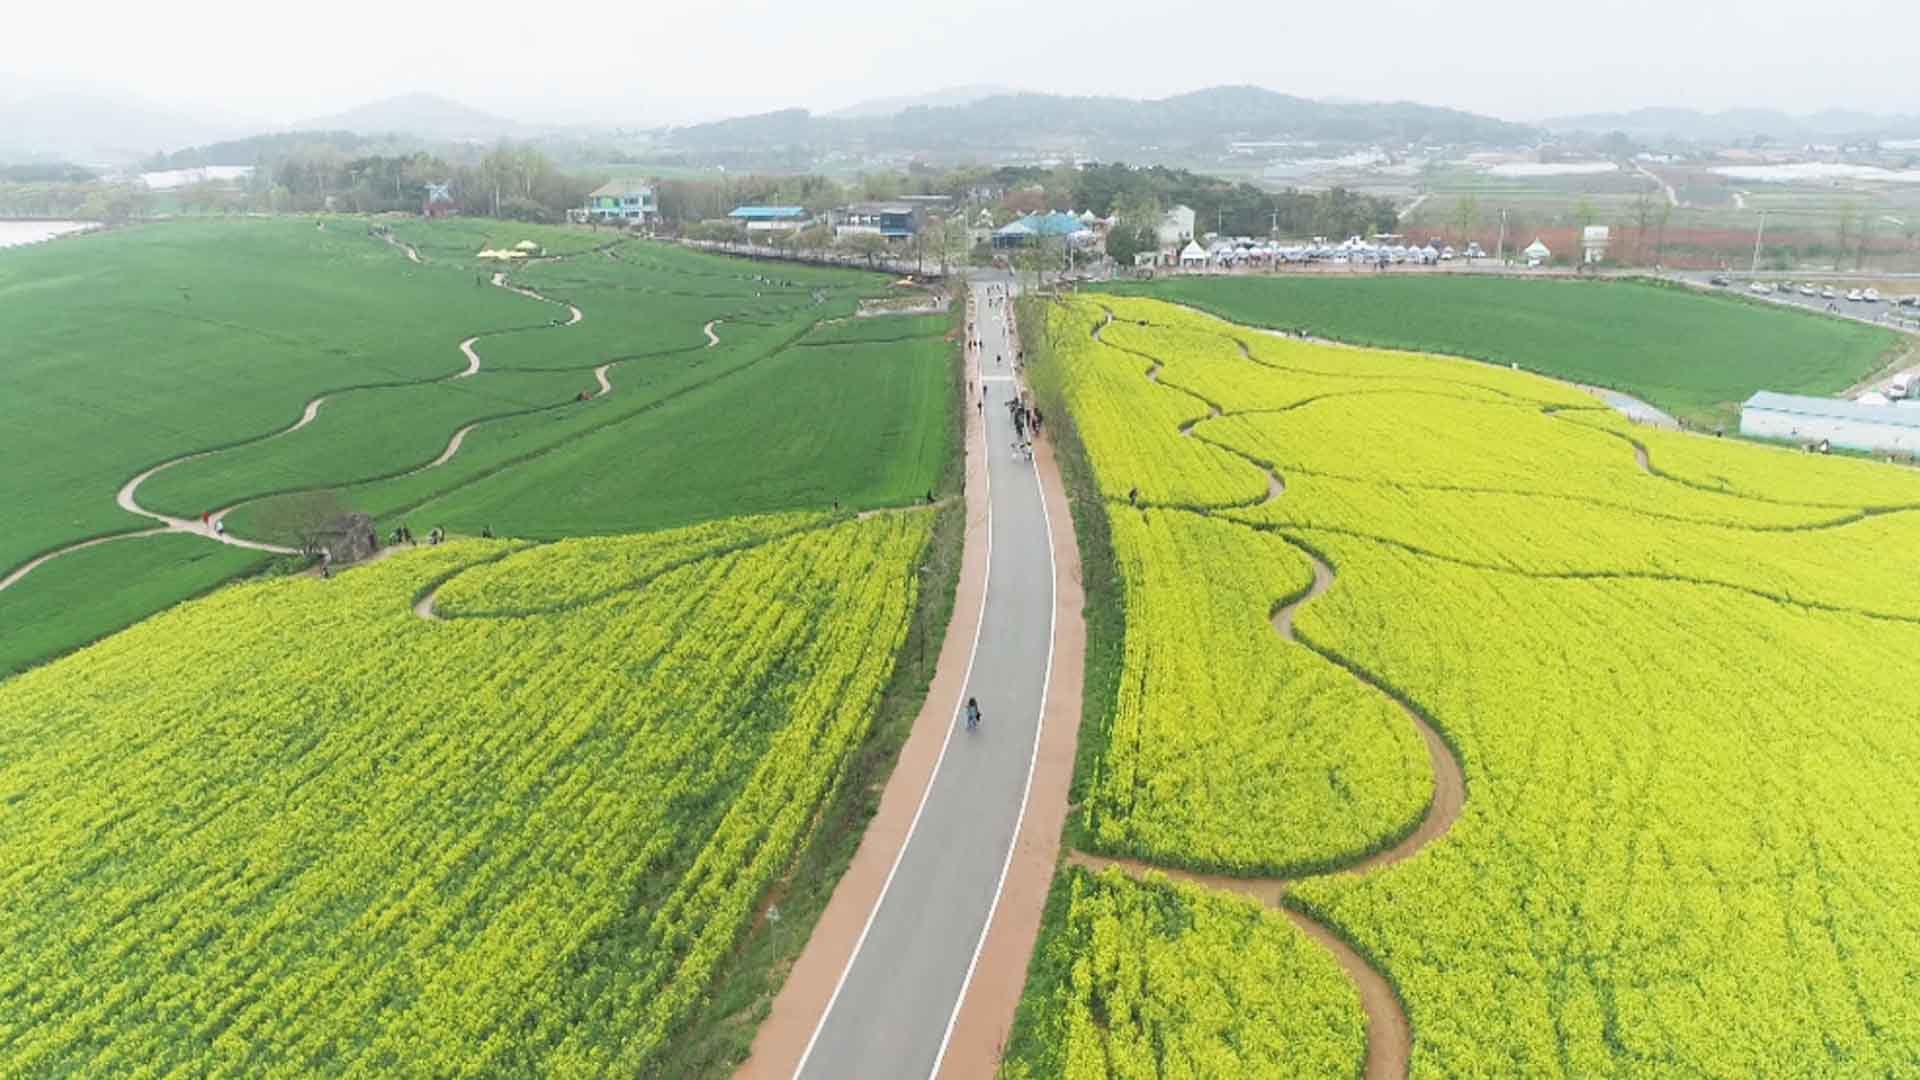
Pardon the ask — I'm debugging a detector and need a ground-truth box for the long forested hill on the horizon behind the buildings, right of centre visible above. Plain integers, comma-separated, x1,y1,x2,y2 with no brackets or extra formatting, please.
670,86,1540,156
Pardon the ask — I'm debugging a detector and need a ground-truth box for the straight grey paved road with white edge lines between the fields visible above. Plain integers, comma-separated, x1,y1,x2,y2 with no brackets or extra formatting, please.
797,275,1054,1080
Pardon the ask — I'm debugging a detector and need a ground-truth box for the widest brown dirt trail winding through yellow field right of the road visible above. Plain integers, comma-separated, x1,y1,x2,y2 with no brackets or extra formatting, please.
1068,294,1466,1080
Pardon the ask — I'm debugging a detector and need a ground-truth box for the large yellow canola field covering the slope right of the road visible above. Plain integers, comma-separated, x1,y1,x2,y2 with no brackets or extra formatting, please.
1025,298,1920,1078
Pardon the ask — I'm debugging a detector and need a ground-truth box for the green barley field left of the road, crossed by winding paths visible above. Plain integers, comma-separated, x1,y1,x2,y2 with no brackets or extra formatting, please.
0,217,956,675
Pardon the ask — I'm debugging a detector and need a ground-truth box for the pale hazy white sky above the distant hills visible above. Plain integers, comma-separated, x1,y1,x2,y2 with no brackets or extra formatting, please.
11,0,1920,127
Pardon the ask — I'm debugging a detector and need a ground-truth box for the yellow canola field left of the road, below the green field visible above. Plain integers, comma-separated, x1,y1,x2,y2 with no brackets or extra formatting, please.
0,515,931,1076
